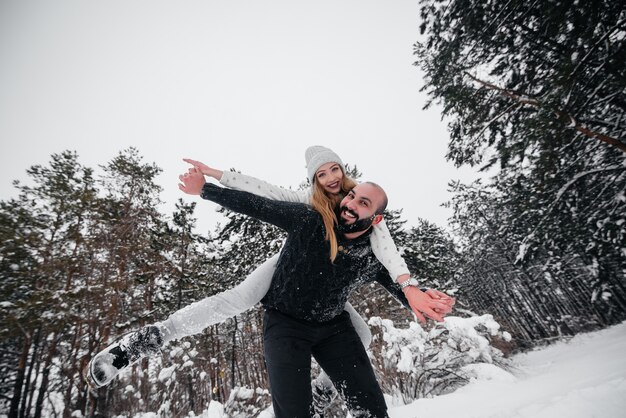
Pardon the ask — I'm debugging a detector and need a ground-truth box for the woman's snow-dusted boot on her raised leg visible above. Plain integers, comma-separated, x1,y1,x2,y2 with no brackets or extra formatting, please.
84,326,163,389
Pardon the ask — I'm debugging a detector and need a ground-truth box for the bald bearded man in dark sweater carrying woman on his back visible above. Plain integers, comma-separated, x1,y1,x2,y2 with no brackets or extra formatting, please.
179,170,451,418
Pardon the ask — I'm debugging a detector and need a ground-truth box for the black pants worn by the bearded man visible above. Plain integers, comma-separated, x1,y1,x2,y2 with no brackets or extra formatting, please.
264,310,388,418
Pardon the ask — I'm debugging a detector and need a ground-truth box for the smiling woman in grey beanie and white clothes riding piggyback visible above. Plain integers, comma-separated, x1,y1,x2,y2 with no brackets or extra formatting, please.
86,146,453,394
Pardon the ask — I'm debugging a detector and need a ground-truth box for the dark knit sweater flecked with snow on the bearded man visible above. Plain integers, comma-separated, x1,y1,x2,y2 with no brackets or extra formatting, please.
201,183,409,322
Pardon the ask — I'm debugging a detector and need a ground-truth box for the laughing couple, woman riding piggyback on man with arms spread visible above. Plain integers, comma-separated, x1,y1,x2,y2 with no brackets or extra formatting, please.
88,146,454,418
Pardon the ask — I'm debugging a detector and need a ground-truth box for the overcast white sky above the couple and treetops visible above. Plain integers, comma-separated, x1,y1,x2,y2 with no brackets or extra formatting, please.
0,0,473,233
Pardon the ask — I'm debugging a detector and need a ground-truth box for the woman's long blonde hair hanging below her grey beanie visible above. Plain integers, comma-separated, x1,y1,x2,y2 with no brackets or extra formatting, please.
311,173,356,262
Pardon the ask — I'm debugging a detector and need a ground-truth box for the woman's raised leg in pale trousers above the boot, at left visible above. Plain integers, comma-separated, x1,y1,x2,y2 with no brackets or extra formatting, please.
155,254,278,343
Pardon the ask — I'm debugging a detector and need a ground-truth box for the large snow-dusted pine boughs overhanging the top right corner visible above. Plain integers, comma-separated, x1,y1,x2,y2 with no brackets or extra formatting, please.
416,0,626,166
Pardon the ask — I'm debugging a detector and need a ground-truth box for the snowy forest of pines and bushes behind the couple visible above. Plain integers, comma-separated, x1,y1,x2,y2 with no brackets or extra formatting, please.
0,0,626,418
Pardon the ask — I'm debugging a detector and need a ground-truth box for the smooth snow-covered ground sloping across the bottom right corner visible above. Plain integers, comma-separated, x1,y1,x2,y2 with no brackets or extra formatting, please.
389,323,626,418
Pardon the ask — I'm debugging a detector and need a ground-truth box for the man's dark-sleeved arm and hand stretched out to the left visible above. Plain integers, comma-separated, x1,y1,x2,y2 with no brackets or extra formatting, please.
178,171,312,231
